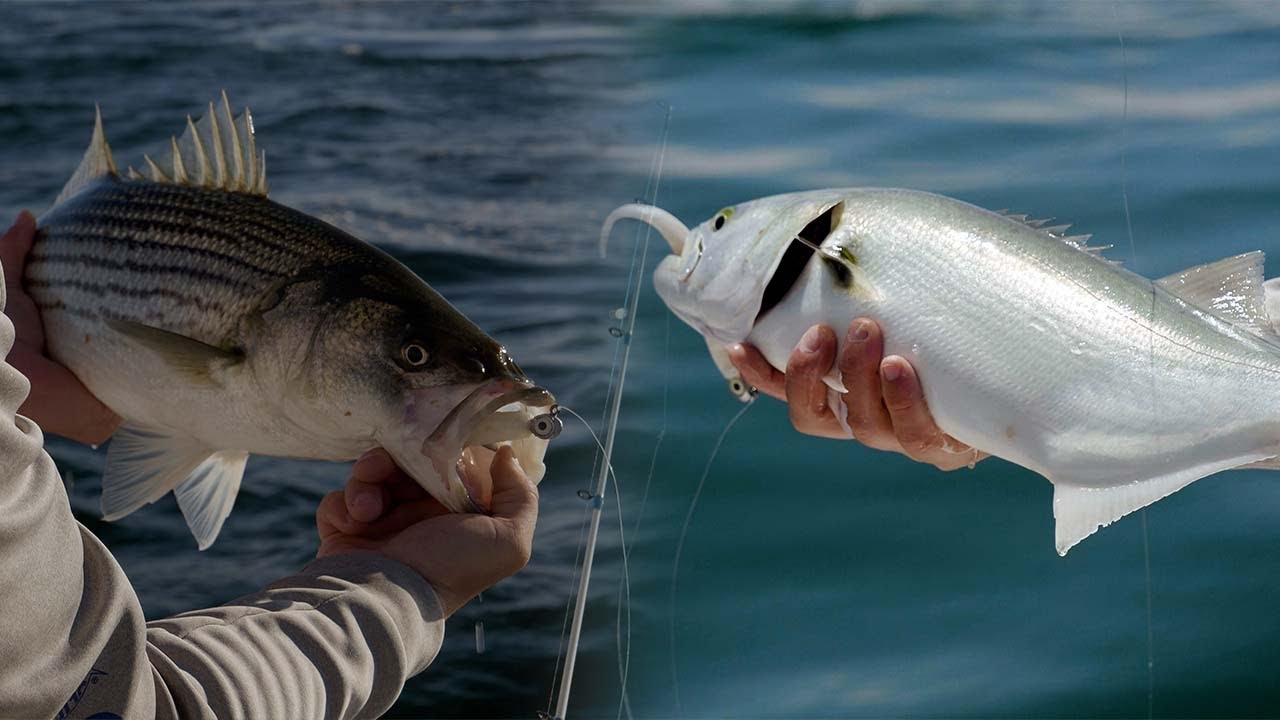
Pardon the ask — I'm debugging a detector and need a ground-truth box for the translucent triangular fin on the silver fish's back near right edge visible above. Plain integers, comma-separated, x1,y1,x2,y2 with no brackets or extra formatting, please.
1156,250,1280,343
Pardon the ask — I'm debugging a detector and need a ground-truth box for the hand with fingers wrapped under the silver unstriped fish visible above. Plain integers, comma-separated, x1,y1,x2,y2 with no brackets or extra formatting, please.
728,318,987,470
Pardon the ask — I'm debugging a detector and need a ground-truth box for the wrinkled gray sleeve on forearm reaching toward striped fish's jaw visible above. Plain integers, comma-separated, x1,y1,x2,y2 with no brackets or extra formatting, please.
147,555,444,717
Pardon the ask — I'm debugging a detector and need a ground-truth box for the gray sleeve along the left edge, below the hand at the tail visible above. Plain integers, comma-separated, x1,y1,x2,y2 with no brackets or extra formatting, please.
0,283,155,717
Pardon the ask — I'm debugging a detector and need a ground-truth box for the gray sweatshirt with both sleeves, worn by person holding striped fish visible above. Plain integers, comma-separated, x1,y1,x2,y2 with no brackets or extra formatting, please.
0,269,444,719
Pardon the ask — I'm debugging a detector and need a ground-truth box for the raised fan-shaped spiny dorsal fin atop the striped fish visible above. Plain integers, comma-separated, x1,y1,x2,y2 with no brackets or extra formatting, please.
152,92,266,197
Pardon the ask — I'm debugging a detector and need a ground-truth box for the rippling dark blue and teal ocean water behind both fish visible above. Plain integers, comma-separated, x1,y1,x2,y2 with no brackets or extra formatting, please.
0,3,1280,717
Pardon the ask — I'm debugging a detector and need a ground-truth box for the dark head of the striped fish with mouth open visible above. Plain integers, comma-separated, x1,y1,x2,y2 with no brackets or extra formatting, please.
293,269,559,512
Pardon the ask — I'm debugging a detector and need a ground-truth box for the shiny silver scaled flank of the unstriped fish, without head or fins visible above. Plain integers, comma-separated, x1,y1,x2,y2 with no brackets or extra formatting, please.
748,196,1280,487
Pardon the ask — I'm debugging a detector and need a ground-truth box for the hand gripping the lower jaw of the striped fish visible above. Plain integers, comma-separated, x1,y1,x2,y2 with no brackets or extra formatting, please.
316,447,538,615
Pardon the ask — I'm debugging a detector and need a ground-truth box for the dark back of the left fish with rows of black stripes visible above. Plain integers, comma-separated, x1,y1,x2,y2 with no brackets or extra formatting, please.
24,178,401,345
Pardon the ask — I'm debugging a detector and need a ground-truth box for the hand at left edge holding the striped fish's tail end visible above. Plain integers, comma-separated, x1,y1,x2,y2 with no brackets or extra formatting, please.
0,210,120,446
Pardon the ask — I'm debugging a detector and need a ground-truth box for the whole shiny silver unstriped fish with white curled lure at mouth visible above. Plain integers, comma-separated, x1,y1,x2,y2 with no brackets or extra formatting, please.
602,188,1280,555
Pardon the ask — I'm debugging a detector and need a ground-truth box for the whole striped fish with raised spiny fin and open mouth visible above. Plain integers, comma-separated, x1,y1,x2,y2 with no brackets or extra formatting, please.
24,94,558,550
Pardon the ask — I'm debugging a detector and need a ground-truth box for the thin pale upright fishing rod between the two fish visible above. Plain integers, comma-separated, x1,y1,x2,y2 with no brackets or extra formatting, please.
556,106,671,720
